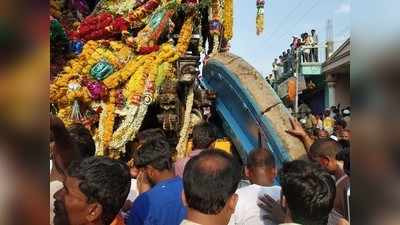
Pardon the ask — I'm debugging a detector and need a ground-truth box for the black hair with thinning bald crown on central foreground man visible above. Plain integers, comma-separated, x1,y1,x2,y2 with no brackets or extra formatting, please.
183,149,241,215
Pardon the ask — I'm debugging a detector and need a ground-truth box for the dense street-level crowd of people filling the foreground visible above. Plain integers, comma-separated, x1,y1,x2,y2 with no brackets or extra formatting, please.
50,102,350,225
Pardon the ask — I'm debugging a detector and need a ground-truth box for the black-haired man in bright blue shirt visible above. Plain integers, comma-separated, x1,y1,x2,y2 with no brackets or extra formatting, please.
127,138,186,225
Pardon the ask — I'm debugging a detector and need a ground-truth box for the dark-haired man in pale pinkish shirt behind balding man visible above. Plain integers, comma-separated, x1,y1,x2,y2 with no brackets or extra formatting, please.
175,122,217,177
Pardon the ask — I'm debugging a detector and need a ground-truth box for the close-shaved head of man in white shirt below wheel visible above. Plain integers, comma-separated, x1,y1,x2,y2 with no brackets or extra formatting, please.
245,148,277,186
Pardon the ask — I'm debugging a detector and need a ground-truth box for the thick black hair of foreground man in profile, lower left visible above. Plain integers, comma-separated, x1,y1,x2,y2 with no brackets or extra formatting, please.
68,156,131,224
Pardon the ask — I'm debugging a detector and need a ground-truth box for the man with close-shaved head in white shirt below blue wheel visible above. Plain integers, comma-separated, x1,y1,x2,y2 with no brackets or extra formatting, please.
229,148,281,225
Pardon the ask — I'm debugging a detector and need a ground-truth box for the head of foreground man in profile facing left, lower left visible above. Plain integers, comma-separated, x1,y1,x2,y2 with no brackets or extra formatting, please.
54,156,131,225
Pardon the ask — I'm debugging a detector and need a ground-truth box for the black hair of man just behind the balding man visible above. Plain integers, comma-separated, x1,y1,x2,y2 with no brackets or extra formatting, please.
192,122,217,149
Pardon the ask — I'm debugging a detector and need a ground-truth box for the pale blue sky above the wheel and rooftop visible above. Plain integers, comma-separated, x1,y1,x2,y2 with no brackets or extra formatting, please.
231,0,352,77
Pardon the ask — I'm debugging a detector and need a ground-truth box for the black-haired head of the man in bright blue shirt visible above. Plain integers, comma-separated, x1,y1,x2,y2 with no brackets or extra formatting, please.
133,138,172,186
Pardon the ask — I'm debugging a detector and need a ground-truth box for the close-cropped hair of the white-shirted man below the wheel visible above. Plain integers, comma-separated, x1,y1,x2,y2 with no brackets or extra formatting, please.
247,148,275,168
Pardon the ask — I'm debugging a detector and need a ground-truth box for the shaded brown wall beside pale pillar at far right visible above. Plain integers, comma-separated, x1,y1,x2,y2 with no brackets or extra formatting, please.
335,74,351,106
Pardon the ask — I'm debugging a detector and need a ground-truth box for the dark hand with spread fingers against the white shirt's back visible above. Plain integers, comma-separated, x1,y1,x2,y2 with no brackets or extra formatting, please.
257,195,286,224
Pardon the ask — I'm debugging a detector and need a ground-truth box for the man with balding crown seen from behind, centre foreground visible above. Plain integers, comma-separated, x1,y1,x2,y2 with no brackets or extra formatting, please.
181,149,240,225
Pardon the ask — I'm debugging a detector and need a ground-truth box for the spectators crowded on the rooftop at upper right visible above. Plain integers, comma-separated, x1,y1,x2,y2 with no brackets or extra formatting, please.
272,29,319,79
